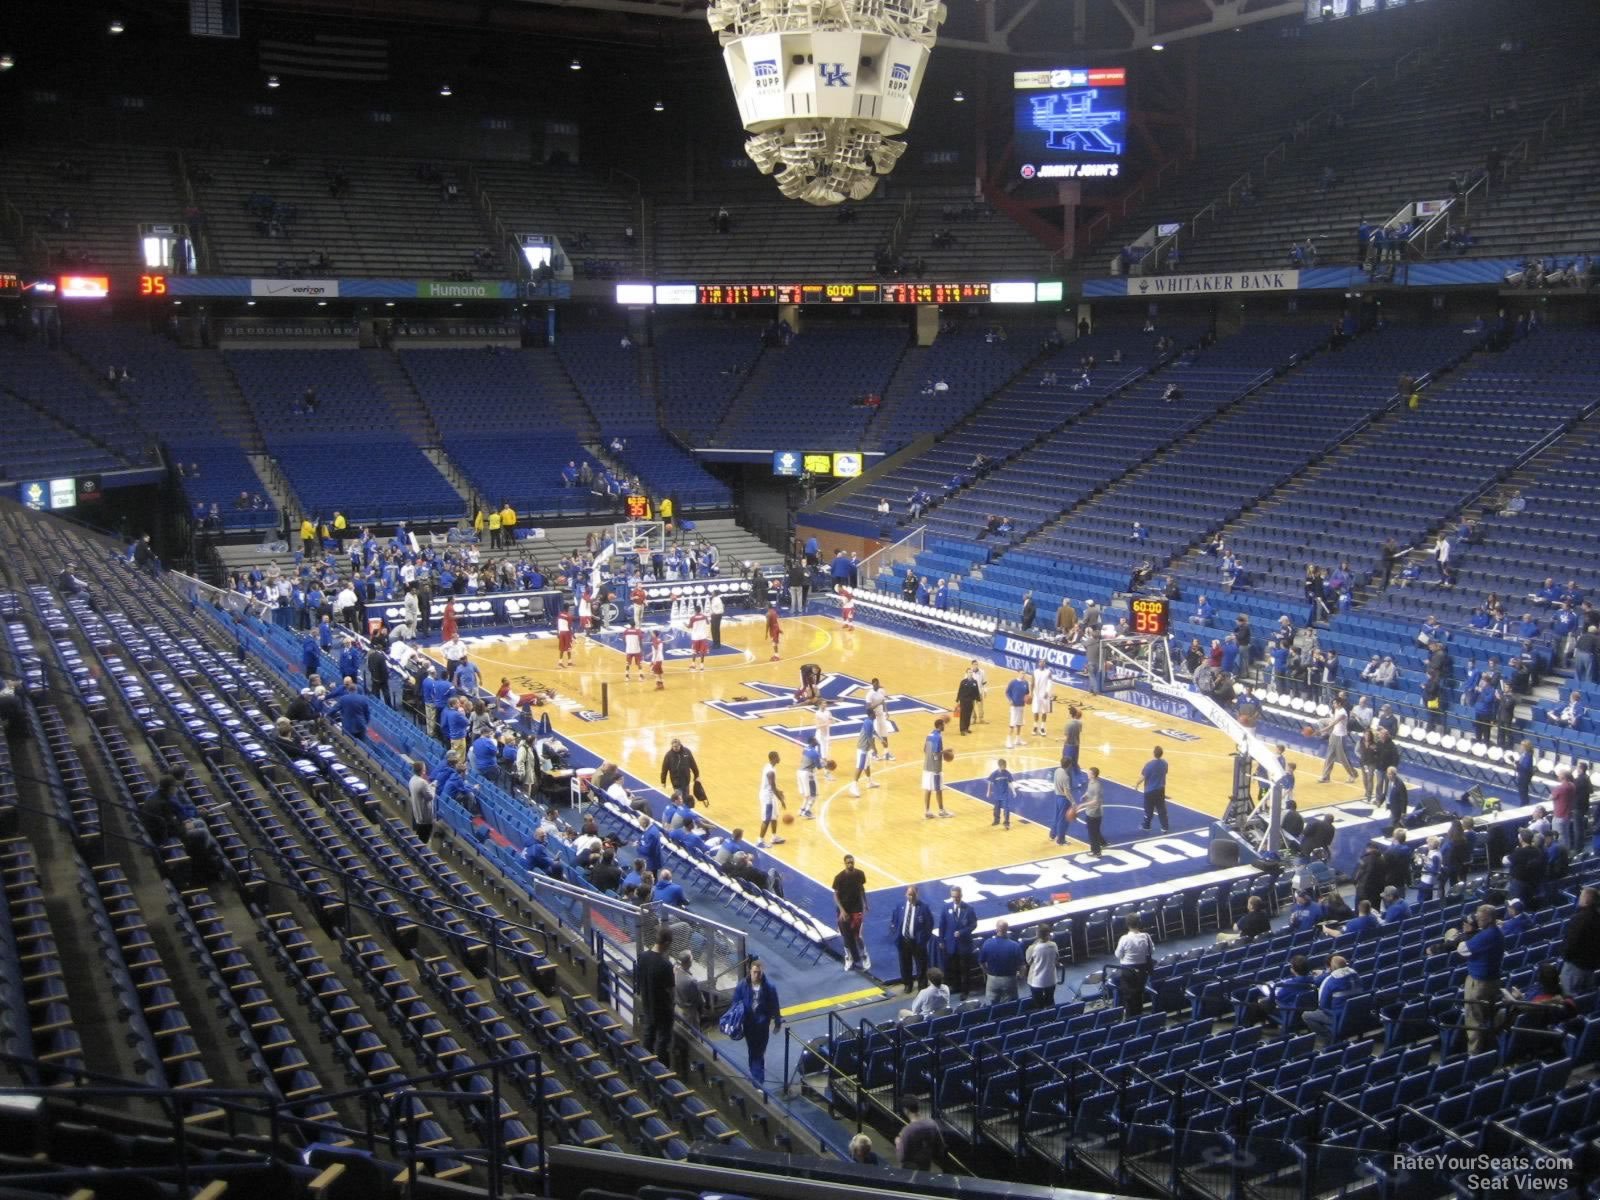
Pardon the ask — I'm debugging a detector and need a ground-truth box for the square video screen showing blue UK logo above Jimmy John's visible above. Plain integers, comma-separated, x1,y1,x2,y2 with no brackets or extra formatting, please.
1011,67,1128,179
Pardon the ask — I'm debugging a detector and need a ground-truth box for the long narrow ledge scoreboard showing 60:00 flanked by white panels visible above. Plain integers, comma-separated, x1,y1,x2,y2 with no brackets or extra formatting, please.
616,280,1066,307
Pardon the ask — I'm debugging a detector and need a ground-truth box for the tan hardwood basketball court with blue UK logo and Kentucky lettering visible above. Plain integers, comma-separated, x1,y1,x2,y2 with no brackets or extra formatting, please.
428,614,1362,960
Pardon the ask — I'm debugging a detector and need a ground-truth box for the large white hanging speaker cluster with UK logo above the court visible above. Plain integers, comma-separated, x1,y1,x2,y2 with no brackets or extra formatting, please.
706,0,946,205
